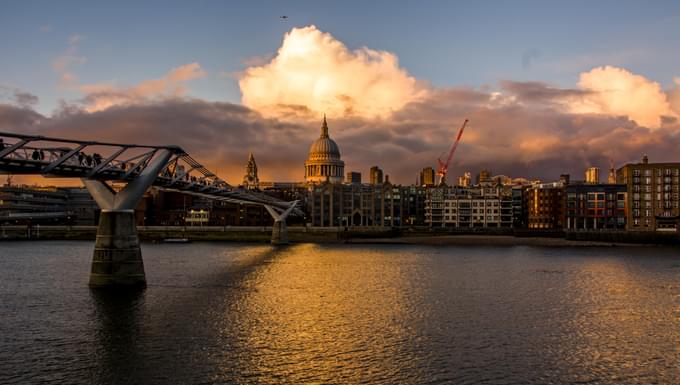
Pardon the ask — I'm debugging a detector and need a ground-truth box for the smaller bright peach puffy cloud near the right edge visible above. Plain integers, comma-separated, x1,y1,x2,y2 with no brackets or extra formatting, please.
569,66,678,128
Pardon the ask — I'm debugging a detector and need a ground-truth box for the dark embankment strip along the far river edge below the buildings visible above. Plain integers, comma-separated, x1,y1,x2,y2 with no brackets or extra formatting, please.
0,226,680,247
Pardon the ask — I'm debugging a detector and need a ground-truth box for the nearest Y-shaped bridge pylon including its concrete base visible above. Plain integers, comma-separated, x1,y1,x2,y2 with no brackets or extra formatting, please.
83,150,173,288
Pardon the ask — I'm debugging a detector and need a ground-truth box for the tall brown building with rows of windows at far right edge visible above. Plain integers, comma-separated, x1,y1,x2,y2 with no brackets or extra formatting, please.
616,155,680,231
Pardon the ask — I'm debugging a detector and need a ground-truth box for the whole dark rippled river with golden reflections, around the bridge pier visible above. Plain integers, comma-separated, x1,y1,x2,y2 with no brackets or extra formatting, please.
0,241,680,384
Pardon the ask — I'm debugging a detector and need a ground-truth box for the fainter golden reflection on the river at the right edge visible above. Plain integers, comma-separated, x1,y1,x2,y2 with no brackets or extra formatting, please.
563,258,680,382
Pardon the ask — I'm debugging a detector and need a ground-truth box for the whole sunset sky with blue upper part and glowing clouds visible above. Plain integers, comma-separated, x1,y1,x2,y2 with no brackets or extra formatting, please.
0,1,680,184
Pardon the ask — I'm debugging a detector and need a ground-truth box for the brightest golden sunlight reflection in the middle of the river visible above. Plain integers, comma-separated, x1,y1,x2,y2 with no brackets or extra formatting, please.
223,244,428,383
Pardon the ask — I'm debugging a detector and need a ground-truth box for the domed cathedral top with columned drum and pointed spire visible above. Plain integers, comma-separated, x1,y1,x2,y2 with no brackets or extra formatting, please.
305,115,345,183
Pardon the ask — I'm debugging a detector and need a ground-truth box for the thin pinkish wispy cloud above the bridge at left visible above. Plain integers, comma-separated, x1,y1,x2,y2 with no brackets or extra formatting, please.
77,62,206,112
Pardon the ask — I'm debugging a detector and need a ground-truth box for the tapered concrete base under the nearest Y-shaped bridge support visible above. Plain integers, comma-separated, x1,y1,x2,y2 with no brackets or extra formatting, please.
90,210,146,288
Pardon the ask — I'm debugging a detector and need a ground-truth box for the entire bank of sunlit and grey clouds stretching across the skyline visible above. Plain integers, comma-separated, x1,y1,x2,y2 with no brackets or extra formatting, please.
5,27,680,184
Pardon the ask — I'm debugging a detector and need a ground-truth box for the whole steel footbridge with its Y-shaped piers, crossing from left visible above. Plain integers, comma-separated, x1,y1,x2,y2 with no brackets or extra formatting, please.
0,132,302,287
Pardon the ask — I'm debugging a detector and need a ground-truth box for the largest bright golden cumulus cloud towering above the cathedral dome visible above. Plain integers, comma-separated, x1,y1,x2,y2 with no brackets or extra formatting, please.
239,25,427,117
